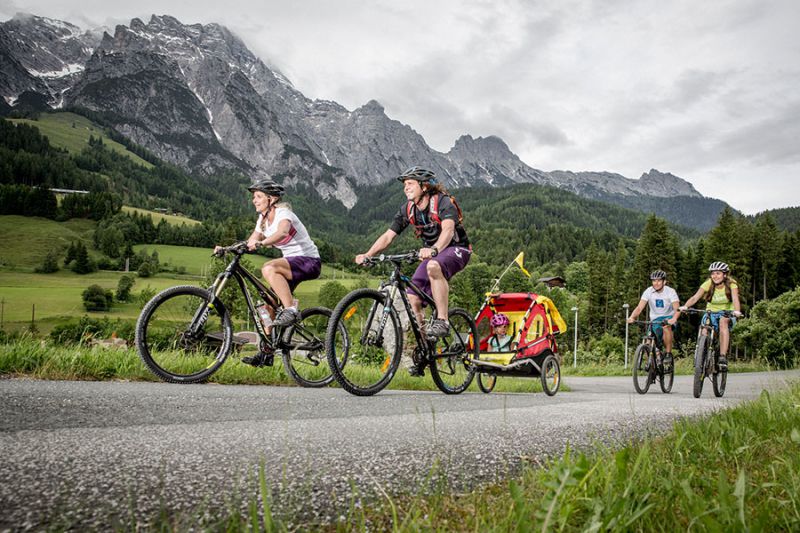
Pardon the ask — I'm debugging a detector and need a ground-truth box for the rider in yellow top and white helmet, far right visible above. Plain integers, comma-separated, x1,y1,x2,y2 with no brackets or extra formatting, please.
681,261,742,371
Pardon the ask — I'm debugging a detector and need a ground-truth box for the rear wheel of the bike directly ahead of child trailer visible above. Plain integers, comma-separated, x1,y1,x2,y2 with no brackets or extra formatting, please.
431,309,479,394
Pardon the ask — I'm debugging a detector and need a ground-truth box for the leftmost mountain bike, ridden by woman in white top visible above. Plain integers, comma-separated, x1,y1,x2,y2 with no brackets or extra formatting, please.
136,242,346,387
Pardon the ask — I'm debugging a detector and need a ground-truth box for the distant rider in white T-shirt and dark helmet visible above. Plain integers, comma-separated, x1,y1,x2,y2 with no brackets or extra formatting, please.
628,270,680,372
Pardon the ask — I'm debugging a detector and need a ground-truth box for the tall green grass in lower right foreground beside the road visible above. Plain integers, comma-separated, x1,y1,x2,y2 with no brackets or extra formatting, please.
354,384,800,531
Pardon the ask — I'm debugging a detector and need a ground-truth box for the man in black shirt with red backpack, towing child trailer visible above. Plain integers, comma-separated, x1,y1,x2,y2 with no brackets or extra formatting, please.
355,167,472,375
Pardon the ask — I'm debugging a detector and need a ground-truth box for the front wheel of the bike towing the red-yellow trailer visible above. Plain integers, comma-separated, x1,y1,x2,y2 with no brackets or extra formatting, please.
325,289,403,396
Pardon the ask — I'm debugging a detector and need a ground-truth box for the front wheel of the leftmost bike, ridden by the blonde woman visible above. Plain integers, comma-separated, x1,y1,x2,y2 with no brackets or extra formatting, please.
136,285,233,383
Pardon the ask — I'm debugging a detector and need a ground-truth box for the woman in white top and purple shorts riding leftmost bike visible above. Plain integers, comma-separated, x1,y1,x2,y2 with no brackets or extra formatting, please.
215,179,322,366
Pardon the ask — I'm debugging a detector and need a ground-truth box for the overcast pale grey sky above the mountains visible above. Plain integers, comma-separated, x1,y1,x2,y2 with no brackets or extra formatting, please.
0,0,800,213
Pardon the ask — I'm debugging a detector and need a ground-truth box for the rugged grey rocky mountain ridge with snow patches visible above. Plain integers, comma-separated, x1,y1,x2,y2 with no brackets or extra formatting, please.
0,15,724,225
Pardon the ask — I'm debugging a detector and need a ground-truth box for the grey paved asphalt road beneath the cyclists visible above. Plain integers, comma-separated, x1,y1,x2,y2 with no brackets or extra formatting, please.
0,371,800,530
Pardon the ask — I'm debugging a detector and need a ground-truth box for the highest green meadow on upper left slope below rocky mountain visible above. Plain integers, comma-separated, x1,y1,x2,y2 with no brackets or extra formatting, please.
10,113,153,168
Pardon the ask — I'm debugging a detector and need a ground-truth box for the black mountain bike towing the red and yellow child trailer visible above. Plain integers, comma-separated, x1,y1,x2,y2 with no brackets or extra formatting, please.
326,251,479,396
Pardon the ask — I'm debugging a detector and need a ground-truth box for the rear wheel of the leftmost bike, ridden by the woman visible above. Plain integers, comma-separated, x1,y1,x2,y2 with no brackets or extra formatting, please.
283,307,345,387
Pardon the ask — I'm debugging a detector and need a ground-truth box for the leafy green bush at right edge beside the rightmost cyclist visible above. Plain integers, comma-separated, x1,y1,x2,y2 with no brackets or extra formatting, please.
733,287,800,368
